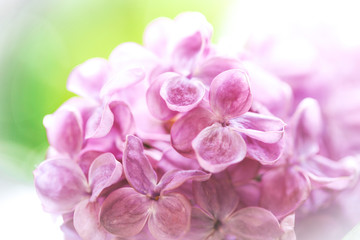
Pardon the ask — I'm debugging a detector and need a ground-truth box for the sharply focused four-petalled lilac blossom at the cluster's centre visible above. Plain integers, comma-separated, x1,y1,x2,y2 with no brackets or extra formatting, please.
171,69,285,172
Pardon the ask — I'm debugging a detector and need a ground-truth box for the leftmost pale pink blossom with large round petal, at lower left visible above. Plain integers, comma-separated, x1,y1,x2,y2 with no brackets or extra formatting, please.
34,153,122,240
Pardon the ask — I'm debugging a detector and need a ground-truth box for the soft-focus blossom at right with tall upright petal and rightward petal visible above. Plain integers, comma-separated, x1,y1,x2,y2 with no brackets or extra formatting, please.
260,98,358,217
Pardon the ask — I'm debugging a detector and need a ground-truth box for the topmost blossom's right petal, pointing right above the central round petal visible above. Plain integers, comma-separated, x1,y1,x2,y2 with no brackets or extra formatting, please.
193,56,242,86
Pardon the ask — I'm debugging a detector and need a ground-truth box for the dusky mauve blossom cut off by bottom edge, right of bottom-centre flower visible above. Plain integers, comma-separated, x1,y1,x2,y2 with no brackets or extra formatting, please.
187,173,283,240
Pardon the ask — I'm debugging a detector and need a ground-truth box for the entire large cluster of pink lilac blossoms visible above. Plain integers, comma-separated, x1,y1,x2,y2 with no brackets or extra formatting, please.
34,13,359,240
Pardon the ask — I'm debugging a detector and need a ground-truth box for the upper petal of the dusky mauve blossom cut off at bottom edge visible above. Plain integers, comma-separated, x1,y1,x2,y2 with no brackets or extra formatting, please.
193,173,239,220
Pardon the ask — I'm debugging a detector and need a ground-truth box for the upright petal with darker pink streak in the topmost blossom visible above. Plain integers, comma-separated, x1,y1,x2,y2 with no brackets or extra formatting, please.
171,32,203,76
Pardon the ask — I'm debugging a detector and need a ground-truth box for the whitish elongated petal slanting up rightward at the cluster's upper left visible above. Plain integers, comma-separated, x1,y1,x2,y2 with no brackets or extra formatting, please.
100,68,146,99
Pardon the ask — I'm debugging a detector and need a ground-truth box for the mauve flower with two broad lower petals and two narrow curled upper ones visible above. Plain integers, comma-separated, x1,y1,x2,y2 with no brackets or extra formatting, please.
100,135,210,239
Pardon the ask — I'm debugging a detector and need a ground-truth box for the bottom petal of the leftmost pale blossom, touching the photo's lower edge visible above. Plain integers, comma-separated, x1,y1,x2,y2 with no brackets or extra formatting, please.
74,200,109,240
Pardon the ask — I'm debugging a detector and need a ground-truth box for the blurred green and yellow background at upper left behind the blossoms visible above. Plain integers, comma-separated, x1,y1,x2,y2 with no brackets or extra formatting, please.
0,0,232,181
